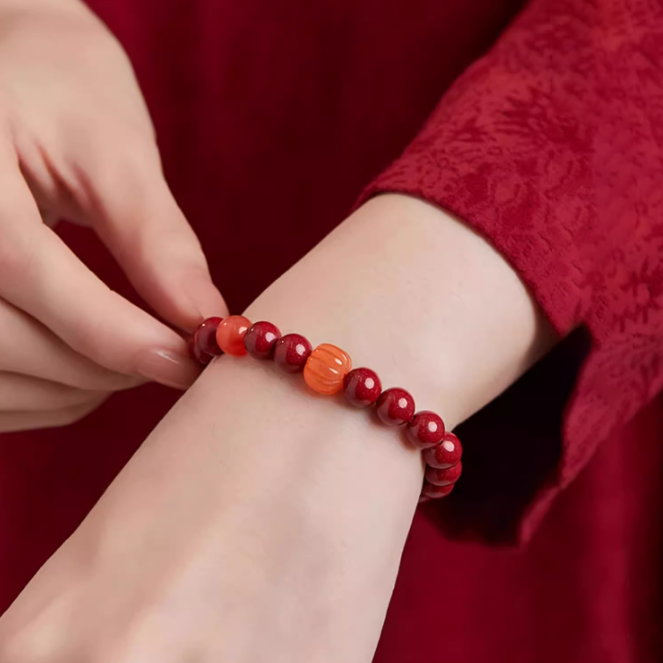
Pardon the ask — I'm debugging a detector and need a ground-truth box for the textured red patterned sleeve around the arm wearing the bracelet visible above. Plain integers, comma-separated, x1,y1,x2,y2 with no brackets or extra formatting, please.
362,0,663,538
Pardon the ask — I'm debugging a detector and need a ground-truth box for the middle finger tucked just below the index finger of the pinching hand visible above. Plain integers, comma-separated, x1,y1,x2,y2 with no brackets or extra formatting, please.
0,300,145,392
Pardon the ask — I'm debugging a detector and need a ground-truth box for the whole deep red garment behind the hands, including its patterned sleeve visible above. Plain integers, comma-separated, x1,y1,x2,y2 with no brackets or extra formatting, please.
0,0,663,663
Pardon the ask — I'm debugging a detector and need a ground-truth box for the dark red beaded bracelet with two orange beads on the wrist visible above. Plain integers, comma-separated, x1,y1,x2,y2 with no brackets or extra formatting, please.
189,315,463,502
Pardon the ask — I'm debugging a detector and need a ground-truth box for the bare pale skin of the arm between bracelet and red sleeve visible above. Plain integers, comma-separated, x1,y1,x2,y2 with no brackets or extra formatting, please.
241,194,555,428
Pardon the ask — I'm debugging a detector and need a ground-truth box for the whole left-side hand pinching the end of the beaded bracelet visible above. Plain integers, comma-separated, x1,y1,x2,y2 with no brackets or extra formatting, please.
0,0,225,432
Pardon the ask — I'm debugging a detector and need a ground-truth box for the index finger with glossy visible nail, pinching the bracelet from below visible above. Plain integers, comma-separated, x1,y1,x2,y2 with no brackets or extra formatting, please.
0,168,204,388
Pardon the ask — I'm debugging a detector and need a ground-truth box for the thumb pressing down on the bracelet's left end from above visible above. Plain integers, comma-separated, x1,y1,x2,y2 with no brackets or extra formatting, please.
68,134,226,329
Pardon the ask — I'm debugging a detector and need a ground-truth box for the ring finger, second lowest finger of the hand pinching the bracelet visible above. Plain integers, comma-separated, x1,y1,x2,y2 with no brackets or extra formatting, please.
0,372,106,414
